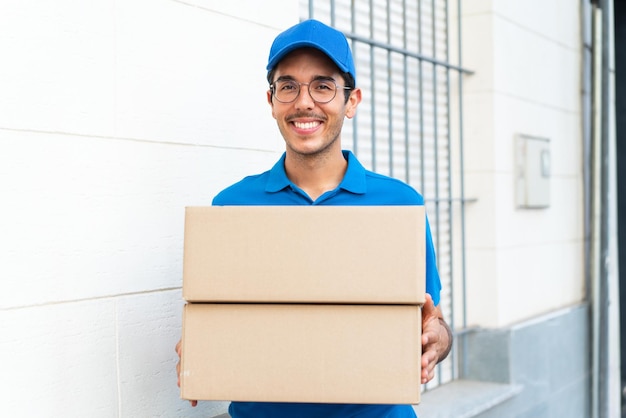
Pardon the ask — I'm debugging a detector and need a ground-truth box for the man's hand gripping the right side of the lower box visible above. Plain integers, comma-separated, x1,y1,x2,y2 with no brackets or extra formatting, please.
422,294,452,384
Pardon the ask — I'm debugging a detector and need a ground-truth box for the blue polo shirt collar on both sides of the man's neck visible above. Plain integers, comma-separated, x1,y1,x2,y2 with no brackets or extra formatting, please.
265,150,366,194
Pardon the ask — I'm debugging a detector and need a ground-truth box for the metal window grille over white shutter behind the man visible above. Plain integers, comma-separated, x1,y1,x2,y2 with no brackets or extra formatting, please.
300,0,470,389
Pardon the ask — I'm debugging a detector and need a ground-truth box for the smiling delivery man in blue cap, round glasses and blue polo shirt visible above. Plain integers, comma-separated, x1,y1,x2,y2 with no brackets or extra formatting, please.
176,20,452,418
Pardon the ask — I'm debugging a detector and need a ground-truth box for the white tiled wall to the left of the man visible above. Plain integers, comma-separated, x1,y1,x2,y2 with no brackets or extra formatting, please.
0,0,298,417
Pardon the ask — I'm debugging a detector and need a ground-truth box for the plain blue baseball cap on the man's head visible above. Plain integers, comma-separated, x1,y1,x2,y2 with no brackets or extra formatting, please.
266,19,356,82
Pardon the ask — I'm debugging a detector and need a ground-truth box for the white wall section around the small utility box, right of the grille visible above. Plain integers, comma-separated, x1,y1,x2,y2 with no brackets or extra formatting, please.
462,0,584,327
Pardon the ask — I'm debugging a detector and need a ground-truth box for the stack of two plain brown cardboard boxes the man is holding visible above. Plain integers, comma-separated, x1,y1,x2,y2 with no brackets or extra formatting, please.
181,206,425,404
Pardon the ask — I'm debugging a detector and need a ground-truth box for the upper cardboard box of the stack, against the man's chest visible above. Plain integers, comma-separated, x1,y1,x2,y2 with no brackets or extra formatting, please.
183,206,426,304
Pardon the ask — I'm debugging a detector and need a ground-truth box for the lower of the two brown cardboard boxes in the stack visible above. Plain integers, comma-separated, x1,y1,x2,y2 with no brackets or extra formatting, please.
181,303,421,404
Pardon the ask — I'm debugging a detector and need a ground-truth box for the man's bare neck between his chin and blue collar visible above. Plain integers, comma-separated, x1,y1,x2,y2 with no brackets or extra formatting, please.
285,150,348,200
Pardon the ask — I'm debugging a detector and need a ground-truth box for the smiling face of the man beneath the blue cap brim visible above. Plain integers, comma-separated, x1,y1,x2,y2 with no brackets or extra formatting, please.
267,48,361,156
